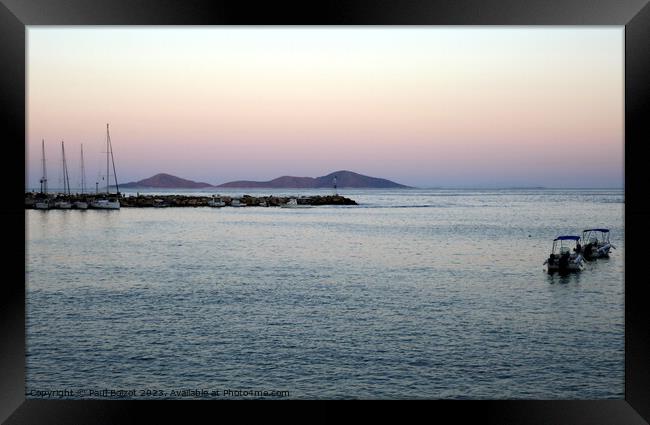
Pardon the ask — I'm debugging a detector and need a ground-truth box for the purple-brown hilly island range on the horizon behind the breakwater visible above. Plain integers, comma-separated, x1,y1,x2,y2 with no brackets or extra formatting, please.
120,170,410,189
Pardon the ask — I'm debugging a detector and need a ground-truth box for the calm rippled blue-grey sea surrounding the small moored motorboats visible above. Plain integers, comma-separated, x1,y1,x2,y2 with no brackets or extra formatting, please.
25,190,625,399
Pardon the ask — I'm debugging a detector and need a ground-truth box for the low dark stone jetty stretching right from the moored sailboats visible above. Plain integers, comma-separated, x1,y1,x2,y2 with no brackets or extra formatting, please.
25,192,357,208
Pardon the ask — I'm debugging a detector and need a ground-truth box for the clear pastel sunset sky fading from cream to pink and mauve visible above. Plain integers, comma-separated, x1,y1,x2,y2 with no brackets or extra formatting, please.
26,26,624,188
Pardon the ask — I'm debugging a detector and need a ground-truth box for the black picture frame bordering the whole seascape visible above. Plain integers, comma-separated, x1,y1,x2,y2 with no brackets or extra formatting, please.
0,0,650,424
